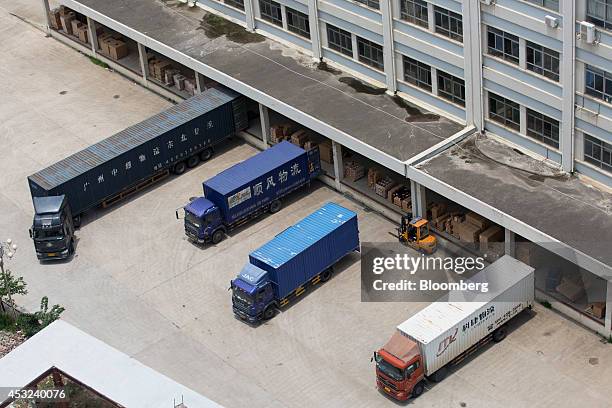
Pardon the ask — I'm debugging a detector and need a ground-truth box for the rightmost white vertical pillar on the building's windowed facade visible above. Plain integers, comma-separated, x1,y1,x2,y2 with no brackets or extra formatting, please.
560,0,576,172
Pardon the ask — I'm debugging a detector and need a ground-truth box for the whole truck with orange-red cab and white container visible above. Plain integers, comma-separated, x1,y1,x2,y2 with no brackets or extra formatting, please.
374,255,534,401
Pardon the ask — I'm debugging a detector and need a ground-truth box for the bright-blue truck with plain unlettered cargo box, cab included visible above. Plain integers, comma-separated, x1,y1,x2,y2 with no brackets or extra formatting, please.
231,203,359,323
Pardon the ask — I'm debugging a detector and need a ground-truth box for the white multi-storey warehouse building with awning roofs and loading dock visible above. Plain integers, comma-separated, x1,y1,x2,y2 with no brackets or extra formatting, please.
42,0,612,335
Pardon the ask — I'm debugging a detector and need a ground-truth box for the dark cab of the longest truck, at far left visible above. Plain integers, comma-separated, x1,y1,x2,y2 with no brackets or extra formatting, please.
30,195,74,260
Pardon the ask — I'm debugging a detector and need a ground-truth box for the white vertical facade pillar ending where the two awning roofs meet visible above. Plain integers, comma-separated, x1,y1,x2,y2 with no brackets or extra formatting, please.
462,1,484,131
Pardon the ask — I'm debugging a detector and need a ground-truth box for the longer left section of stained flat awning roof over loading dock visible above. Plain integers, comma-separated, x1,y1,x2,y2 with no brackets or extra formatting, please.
62,0,463,175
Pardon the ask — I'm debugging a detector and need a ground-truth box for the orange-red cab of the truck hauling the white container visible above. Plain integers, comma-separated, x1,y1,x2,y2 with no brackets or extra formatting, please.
374,332,425,401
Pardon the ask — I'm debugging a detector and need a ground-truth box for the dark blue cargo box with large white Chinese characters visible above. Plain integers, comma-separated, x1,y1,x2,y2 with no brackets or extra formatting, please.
204,141,318,224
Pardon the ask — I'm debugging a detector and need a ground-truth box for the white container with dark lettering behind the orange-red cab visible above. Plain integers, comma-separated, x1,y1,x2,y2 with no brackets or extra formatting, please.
397,255,534,375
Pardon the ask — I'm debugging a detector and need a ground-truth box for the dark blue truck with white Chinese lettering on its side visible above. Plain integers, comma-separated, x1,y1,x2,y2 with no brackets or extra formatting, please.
176,141,321,244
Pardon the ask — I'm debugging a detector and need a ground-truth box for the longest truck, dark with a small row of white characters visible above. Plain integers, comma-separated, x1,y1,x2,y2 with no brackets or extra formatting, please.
28,88,248,260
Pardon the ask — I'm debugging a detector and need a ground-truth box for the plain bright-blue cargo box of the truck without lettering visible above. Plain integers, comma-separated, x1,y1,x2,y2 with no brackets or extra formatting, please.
249,203,359,299
